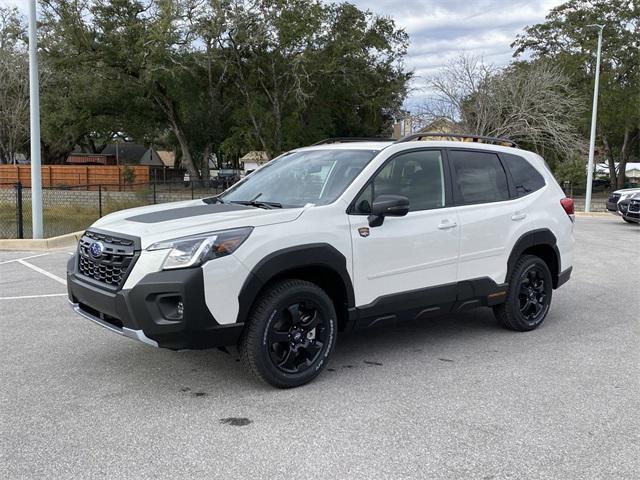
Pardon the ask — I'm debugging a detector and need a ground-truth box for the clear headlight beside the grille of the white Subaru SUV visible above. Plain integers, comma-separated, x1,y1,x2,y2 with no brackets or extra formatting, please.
147,227,253,270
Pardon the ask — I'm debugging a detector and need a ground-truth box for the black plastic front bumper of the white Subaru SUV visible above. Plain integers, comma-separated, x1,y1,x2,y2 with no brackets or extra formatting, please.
67,255,244,350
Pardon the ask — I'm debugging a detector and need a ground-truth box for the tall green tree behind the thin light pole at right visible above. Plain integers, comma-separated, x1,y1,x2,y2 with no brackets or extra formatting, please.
512,0,640,188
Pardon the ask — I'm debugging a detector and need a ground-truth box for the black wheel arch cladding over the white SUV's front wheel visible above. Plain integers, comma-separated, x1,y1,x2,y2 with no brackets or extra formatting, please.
237,243,355,322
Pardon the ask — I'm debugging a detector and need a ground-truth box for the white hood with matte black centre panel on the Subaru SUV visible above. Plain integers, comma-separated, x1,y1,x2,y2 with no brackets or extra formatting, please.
90,200,304,249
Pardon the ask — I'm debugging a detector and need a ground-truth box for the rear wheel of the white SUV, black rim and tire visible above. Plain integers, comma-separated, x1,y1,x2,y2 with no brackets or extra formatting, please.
493,255,553,332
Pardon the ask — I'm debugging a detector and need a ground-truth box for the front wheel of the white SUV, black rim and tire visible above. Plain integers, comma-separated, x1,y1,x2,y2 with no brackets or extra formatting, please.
239,279,338,388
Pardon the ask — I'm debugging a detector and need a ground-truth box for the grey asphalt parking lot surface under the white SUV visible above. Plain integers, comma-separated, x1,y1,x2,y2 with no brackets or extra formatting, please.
0,216,640,479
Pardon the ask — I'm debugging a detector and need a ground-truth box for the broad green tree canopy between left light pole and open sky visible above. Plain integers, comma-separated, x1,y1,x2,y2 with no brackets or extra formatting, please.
41,0,410,171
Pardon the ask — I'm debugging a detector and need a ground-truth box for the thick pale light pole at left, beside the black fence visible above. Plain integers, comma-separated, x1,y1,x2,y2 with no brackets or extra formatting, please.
29,0,43,238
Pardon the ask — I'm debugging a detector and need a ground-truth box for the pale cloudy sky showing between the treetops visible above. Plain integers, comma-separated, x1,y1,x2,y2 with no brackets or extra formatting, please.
5,0,566,105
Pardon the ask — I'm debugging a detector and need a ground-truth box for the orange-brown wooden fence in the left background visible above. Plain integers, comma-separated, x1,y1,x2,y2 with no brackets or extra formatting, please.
0,165,149,190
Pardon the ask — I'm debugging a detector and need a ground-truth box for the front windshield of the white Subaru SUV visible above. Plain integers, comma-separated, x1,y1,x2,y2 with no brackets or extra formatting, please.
219,149,378,207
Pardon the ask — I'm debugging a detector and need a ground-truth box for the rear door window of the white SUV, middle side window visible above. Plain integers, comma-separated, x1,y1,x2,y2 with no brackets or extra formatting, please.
449,150,509,204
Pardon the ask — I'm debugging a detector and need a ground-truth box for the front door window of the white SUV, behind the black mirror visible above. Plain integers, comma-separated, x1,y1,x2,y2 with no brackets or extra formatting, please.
355,150,445,214
